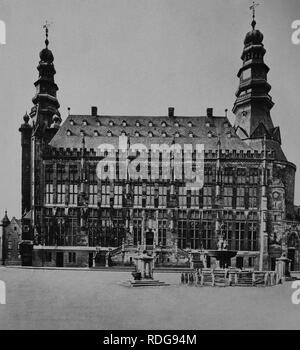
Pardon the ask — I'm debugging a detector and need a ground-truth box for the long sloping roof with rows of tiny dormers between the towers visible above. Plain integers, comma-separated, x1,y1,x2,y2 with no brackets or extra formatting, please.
50,115,254,151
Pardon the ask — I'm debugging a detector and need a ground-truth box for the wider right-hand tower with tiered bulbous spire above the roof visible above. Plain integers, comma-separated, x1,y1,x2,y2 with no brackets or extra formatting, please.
232,3,280,143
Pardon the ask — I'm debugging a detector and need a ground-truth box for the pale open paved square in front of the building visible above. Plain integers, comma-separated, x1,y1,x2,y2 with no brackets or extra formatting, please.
0,267,300,330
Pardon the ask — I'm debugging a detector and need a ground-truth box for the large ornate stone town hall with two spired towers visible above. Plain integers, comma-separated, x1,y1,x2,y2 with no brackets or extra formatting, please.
19,13,300,270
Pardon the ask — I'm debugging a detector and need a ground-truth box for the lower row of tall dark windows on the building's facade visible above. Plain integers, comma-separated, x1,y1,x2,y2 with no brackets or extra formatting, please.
44,212,258,250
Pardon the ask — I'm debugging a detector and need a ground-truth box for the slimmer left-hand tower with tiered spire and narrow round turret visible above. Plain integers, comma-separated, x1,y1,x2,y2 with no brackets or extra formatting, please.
19,22,61,265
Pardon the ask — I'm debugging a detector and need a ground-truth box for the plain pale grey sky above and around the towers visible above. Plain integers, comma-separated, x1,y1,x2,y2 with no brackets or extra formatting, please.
0,0,300,217
